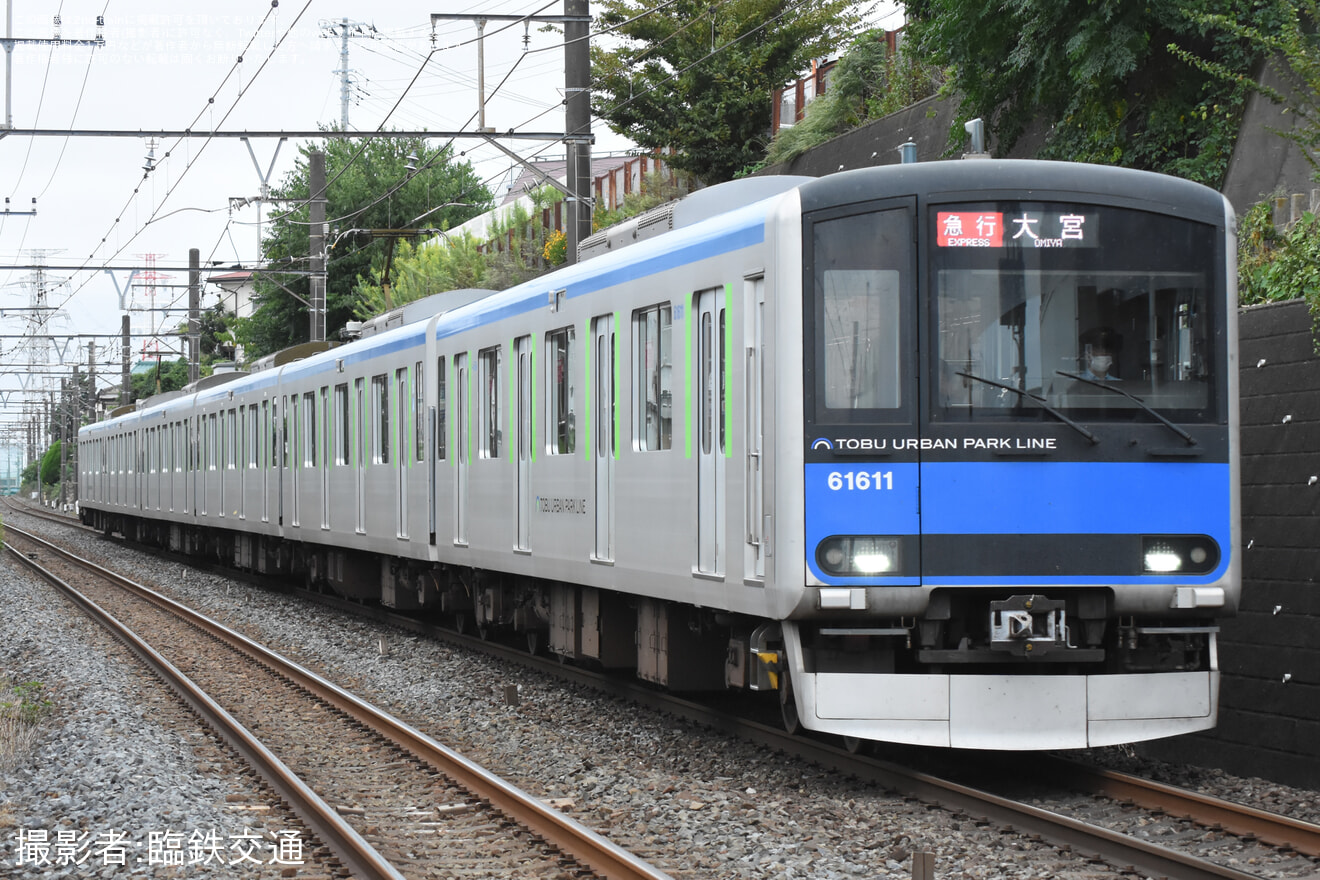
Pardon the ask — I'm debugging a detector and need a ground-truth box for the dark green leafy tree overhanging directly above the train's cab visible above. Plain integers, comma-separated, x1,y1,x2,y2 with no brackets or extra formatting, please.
904,0,1276,186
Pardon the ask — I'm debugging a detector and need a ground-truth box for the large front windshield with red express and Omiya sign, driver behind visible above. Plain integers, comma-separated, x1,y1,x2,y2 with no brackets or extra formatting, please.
928,202,1216,421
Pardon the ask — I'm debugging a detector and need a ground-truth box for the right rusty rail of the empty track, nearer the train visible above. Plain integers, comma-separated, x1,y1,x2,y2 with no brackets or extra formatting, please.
2,526,669,880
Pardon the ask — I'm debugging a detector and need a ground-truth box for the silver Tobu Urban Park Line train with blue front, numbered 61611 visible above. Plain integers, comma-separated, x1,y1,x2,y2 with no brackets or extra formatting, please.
78,158,1241,751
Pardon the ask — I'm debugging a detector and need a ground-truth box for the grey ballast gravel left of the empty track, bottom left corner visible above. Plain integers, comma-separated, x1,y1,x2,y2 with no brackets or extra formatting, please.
0,559,323,879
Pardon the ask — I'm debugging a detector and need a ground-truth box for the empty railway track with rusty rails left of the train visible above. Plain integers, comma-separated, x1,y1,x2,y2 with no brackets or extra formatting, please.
5,524,667,880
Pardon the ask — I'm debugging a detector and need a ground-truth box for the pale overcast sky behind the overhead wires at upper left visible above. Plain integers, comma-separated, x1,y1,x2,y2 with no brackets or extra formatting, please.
0,0,896,464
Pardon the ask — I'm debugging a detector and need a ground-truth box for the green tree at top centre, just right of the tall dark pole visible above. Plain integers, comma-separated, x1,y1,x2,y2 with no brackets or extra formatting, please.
591,0,858,183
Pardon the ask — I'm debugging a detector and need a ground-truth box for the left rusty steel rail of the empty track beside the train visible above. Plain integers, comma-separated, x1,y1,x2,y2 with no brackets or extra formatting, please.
5,525,405,880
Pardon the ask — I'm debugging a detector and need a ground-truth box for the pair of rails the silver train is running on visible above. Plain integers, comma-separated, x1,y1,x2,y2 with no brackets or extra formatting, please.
5,498,1320,877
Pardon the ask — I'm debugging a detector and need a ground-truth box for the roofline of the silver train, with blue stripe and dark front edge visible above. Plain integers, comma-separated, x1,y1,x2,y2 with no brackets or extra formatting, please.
79,158,1225,440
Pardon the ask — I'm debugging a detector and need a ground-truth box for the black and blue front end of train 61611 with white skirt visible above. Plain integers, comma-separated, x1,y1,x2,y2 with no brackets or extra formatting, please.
776,160,1241,749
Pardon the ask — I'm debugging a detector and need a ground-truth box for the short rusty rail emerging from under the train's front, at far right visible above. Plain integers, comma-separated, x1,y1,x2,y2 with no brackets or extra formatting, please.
1053,759,1320,858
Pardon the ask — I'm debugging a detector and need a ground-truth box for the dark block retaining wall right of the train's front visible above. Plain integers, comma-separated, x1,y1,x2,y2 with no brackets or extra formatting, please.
1142,301,1320,788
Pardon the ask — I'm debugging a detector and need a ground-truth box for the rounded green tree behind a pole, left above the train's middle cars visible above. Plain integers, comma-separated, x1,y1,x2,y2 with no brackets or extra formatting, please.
235,137,491,358
